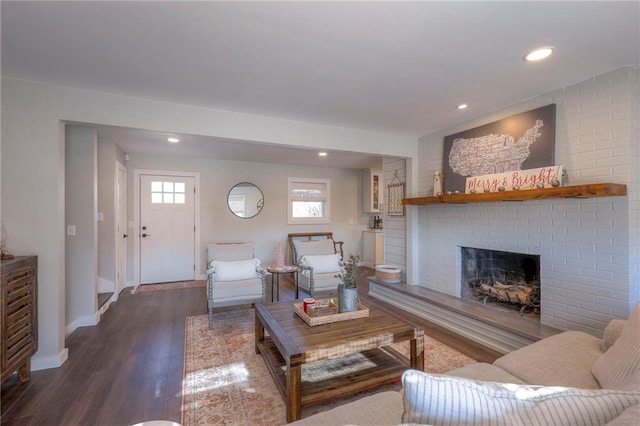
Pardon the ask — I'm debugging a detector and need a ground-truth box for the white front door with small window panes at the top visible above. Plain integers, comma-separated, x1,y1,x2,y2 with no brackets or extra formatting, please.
139,174,195,284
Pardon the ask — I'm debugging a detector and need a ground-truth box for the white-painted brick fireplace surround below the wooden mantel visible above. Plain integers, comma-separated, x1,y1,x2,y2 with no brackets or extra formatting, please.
418,191,628,335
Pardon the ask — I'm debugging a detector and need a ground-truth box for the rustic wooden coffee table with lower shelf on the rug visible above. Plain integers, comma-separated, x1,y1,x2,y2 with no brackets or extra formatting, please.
255,302,424,422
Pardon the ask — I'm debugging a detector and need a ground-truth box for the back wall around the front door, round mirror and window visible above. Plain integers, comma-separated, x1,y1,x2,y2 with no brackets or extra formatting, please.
127,153,369,277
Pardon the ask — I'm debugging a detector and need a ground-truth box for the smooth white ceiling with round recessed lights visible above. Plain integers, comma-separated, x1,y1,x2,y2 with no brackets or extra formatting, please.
0,1,640,167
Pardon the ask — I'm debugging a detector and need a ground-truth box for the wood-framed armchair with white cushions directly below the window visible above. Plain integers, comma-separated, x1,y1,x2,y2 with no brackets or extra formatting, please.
289,232,344,297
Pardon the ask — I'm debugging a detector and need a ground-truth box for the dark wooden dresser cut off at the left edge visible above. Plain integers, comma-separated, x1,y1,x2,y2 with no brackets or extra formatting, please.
0,256,38,382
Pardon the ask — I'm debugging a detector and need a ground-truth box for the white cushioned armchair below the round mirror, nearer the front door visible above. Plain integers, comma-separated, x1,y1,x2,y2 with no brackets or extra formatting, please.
207,242,266,327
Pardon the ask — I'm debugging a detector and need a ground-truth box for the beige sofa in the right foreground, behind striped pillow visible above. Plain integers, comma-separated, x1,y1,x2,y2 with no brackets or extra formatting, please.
291,304,640,426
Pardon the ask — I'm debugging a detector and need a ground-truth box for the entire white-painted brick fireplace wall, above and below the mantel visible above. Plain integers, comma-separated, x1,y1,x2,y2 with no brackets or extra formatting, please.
411,68,640,335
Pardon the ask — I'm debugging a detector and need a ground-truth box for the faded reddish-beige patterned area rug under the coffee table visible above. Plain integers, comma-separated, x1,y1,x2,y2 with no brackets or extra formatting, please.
182,309,476,426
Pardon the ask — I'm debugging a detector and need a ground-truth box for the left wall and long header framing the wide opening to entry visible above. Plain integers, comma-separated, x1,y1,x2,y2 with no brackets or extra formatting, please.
1,78,417,369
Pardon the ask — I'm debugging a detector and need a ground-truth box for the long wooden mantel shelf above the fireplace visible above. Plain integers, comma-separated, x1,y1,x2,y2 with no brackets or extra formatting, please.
402,183,627,205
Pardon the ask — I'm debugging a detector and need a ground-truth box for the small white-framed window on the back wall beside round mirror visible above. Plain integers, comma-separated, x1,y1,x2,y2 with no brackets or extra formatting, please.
288,178,331,224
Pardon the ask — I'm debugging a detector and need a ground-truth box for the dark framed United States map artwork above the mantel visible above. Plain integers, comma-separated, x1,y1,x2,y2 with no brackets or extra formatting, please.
443,104,556,192
